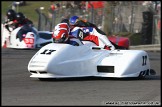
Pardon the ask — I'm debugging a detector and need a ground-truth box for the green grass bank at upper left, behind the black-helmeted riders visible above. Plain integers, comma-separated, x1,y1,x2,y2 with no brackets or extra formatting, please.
1,1,51,23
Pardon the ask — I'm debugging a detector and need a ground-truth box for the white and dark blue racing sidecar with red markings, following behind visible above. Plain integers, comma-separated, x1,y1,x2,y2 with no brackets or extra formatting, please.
1,24,53,49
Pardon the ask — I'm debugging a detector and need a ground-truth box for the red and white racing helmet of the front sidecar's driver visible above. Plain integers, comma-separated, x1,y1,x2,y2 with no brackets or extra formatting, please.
53,23,70,43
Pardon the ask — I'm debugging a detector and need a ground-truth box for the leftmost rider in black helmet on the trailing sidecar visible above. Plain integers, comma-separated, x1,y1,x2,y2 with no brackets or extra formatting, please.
4,9,17,32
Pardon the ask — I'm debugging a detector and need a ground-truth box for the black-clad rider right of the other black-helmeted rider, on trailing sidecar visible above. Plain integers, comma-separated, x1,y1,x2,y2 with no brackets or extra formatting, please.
16,12,33,27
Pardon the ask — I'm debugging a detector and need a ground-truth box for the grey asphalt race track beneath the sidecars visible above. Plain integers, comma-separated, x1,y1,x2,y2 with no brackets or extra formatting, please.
1,49,161,106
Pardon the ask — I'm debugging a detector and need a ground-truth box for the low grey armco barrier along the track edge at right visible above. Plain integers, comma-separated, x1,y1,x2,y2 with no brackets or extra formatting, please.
130,44,161,51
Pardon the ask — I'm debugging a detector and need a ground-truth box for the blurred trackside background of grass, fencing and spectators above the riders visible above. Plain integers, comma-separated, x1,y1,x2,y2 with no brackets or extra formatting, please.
1,1,161,46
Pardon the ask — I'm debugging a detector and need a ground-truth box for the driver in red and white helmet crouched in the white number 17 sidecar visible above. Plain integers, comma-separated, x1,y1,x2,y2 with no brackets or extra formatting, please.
53,23,83,46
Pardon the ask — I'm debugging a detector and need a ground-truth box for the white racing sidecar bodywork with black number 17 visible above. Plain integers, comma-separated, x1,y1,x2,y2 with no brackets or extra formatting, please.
28,41,156,79
